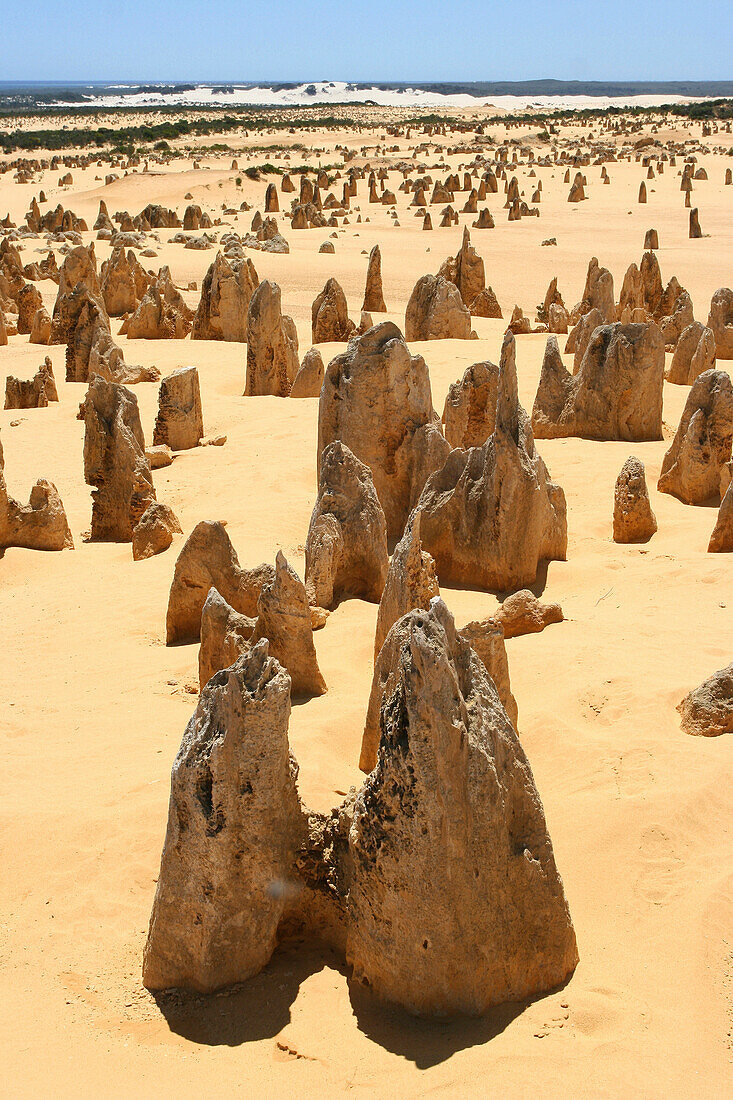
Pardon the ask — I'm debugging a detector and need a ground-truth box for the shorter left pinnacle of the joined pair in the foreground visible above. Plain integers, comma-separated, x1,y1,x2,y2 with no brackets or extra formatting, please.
143,641,305,992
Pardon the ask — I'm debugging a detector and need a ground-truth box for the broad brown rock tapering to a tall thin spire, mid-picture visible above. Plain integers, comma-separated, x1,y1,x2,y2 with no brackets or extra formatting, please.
417,333,568,591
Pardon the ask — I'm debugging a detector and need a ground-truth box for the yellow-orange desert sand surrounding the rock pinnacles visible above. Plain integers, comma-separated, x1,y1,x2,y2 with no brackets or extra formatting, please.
0,116,733,1098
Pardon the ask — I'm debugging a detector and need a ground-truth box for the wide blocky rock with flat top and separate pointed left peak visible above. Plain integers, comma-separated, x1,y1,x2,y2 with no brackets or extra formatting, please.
532,322,665,441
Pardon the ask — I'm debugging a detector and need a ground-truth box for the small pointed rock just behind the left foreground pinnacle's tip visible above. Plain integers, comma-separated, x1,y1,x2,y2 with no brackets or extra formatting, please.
252,550,326,696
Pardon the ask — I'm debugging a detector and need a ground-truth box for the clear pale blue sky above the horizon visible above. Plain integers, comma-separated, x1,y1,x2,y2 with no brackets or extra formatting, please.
0,0,733,81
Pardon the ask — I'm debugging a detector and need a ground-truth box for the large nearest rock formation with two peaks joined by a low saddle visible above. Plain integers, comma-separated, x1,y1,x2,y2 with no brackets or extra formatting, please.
143,601,578,1015
